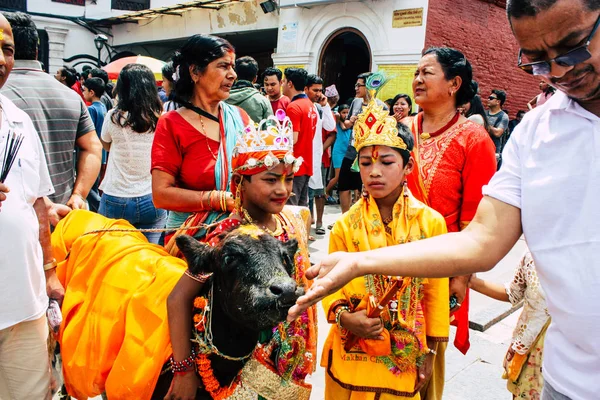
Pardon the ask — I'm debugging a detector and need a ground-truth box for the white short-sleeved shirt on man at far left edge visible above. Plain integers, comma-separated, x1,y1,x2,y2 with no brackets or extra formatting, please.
0,94,54,330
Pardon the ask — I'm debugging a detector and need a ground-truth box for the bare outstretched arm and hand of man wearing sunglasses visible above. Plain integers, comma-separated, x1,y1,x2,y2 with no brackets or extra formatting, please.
288,196,522,320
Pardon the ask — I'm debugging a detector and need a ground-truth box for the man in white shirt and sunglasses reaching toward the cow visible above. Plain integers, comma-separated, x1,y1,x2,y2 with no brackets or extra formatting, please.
288,0,600,400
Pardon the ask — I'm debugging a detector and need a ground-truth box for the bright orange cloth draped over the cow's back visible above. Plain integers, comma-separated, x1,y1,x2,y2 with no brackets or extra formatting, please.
52,210,187,400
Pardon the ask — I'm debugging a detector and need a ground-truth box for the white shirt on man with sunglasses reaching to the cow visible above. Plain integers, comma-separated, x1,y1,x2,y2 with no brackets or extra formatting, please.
483,92,600,400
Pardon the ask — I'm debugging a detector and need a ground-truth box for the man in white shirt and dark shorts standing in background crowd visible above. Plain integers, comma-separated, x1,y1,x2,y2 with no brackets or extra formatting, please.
304,74,335,235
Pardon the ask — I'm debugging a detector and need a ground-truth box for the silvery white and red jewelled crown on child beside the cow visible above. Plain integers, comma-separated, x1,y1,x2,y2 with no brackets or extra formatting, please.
231,110,303,175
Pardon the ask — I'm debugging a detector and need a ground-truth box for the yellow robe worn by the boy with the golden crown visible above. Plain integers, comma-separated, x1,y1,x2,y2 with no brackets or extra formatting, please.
321,191,449,400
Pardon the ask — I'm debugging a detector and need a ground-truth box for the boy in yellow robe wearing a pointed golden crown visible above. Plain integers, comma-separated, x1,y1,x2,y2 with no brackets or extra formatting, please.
321,77,449,400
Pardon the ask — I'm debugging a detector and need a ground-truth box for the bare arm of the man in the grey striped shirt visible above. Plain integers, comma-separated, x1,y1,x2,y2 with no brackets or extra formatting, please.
67,131,102,209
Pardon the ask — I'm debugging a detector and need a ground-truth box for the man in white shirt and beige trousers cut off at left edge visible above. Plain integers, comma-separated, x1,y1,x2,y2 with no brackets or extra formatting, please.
0,16,64,399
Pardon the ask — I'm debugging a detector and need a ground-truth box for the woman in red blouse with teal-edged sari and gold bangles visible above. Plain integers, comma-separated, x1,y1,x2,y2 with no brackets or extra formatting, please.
151,35,250,254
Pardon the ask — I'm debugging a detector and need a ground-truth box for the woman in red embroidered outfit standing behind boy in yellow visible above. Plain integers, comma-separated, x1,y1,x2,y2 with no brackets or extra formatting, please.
402,48,496,400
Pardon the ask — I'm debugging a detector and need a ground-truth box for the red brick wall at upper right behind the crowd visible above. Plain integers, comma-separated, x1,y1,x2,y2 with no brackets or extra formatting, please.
425,0,539,119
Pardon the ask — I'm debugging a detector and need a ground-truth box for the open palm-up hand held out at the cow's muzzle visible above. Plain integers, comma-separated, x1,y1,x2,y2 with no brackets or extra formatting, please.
287,252,360,322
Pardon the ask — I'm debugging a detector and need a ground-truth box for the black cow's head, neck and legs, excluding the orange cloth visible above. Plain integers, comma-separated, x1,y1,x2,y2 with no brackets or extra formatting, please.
152,226,304,400
